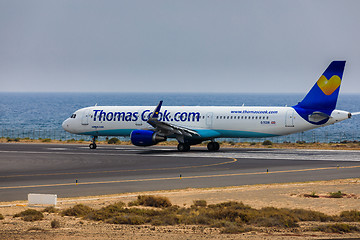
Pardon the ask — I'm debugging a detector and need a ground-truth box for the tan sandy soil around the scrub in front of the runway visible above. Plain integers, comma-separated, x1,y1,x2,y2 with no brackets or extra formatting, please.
0,178,360,239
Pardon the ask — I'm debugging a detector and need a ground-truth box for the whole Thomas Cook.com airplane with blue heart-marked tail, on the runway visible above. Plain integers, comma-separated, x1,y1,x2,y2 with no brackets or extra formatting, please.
62,61,360,152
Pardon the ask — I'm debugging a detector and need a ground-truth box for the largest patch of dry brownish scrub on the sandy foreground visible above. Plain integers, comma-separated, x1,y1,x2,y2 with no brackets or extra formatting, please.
56,195,360,233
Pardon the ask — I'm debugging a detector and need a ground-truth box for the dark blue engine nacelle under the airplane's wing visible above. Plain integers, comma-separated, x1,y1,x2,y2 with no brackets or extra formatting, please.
130,130,167,146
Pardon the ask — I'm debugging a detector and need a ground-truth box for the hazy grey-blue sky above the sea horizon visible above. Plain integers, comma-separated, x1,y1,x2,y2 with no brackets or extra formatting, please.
0,0,360,93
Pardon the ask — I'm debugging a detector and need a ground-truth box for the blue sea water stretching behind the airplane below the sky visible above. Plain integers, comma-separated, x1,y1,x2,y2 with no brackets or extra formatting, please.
0,93,360,142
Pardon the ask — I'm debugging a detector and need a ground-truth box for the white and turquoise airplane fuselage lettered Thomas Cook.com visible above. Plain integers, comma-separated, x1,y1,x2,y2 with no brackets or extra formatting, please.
63,106,349,139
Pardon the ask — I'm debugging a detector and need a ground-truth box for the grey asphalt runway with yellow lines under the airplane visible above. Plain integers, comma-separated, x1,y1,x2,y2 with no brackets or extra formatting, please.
0,144,360,201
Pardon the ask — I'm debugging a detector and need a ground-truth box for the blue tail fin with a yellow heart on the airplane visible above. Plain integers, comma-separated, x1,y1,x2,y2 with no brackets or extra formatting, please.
295,61,345,111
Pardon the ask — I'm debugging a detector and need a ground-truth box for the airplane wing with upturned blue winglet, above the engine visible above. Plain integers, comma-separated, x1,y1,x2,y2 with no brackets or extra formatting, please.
147,101,200,139
